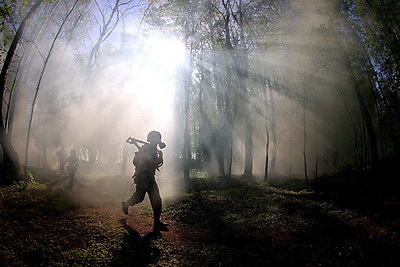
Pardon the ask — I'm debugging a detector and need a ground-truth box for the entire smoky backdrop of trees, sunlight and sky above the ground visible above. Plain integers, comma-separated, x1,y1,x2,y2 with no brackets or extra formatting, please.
0,0,400,185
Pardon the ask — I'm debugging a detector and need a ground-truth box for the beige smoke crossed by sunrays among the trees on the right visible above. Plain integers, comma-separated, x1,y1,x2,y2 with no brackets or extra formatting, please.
198,0,356,177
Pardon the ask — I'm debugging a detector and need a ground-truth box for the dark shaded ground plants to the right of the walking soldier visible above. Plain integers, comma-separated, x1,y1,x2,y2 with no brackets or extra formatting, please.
162,178,400,266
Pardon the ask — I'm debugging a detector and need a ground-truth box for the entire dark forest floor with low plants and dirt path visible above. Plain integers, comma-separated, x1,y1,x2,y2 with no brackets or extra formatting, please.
0,171,400,266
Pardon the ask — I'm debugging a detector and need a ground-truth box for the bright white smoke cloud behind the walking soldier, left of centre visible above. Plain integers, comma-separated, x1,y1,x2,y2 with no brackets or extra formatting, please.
9,21,184,188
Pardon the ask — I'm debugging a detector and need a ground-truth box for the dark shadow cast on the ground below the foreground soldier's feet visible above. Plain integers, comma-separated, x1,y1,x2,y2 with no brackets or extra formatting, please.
111,219,161,266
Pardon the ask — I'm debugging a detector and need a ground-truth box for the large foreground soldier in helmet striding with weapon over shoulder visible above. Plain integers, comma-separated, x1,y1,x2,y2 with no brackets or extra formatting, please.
121,131,168,231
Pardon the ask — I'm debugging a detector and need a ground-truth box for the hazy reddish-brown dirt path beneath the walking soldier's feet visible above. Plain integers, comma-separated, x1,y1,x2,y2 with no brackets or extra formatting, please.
53,174,202,251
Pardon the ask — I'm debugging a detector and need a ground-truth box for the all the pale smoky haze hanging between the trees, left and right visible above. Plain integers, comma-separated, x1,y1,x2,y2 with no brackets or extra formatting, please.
1,1,360,193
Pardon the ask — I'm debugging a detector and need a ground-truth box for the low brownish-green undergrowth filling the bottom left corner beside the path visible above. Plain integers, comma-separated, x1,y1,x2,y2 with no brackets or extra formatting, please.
0,183,123,266
